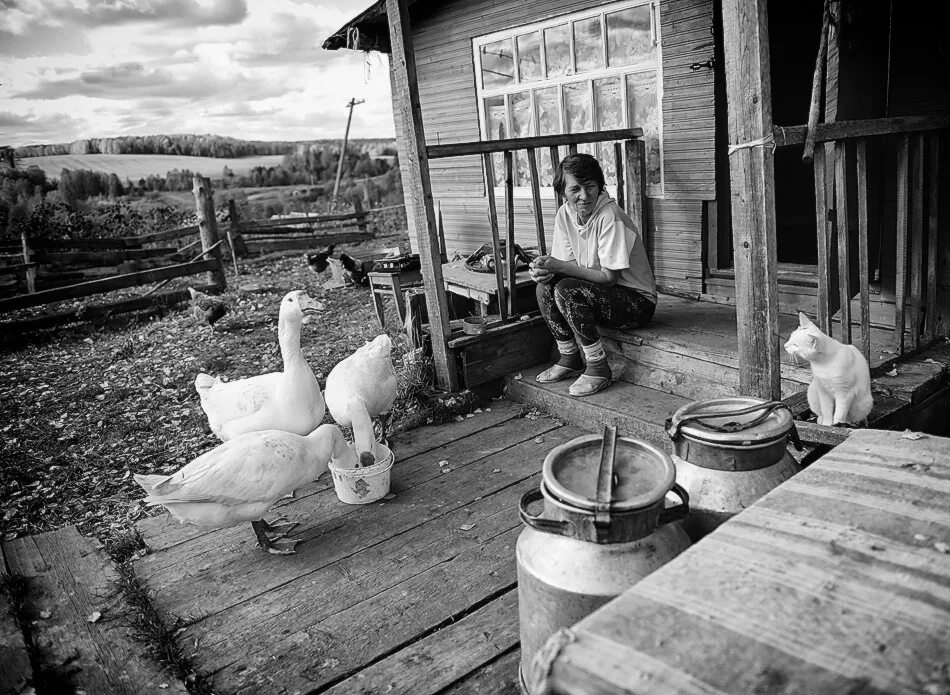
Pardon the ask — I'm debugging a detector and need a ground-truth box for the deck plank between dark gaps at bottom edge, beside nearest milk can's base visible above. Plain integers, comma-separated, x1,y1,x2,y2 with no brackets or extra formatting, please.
324,590,518,695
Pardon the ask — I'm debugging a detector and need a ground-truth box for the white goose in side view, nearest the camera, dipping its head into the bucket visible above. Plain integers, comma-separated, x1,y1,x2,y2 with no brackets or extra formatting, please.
135,424,356,555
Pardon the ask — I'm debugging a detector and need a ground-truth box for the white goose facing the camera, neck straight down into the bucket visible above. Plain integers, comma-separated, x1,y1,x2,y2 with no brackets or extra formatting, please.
325,333,397,465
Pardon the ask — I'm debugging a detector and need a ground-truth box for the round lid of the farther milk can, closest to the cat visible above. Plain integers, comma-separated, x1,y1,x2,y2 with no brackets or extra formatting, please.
667,397,793,445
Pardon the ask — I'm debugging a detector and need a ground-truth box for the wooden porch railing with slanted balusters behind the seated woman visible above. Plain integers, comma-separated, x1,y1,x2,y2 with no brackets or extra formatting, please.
426,128,646,323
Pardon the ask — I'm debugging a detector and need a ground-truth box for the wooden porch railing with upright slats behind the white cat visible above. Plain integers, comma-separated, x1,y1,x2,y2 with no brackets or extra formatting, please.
773,116,950,362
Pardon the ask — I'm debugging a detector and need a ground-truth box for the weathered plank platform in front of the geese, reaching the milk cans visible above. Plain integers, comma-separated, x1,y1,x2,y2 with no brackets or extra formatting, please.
130,401,582,694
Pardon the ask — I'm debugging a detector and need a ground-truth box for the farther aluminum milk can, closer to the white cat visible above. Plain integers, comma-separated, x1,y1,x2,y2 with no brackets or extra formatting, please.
666,397,801,542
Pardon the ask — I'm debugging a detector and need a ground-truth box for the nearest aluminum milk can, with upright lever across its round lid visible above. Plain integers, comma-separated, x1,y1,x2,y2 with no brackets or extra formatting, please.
516,427,689,695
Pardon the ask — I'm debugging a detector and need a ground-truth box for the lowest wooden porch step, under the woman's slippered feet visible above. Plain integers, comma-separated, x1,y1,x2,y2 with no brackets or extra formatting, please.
505,364,692,451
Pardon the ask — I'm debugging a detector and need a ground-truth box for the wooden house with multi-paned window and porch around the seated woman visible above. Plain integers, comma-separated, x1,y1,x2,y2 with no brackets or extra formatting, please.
324,0,950,446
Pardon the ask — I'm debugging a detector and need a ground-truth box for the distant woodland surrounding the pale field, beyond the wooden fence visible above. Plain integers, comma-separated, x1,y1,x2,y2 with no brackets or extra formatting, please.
0,135,402,240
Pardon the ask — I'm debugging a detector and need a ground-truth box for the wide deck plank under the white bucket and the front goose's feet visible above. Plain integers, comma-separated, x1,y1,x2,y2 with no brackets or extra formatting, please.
137,410,564,617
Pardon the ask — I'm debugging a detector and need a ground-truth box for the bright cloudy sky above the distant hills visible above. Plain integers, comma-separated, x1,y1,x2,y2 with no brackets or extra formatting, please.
0,0,394,146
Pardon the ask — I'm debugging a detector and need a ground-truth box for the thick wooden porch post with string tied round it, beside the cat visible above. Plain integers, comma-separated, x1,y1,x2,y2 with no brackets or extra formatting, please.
722,0,782,400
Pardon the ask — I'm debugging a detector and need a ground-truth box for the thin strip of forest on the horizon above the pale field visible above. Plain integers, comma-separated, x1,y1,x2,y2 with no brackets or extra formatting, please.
3,135,394,158
